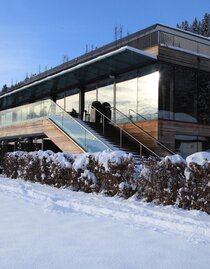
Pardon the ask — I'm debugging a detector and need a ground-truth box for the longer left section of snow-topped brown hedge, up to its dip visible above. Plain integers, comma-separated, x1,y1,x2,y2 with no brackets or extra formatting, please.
3,151,134,196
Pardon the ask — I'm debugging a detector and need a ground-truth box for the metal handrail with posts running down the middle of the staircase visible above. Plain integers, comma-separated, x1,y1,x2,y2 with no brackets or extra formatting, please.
91,105,160,159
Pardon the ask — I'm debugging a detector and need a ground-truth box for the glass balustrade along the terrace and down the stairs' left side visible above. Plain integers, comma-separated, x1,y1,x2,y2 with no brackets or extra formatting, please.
0,100,110,152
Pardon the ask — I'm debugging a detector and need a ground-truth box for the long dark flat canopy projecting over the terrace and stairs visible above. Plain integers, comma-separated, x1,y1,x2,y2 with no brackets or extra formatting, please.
0,46,157,109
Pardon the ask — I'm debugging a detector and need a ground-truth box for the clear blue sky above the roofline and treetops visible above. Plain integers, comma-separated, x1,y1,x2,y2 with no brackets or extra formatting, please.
0,0,210,88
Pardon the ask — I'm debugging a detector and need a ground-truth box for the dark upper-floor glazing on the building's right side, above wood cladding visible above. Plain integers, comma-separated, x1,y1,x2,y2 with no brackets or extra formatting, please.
159,64,210,125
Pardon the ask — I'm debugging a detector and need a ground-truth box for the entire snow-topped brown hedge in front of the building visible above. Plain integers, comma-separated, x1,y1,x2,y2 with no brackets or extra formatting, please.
3,151,210,214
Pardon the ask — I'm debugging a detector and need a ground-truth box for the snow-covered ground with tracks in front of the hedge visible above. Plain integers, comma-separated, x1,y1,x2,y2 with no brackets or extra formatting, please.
0,177,210,269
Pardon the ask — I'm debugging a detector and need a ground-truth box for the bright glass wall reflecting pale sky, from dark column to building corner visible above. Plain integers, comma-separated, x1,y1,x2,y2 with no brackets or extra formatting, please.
82,68,159,120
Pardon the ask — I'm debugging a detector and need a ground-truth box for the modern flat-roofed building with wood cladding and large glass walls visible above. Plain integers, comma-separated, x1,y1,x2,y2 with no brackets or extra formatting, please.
0,24,210,156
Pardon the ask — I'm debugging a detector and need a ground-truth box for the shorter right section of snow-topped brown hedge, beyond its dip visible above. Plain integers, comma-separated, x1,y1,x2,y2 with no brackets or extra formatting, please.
137,152,210,214
